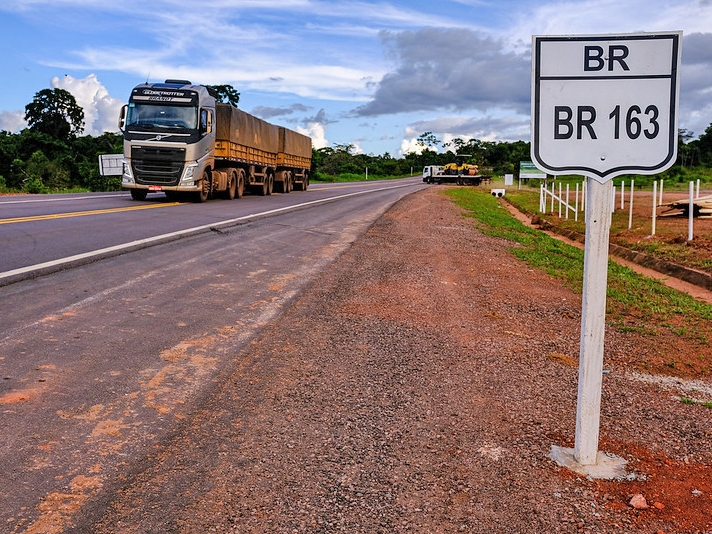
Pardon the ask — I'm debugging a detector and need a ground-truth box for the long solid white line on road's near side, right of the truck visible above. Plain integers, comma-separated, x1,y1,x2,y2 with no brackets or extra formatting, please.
0,184,413,280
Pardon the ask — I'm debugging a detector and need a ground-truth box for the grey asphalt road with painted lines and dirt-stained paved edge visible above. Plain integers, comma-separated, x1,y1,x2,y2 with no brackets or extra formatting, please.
0,177,424,533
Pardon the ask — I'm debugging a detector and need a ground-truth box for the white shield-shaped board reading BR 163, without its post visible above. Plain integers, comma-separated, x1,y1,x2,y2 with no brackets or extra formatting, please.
531,32,682,182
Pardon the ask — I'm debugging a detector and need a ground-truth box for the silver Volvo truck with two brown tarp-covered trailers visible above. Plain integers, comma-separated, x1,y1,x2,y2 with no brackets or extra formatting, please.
119,80,312,202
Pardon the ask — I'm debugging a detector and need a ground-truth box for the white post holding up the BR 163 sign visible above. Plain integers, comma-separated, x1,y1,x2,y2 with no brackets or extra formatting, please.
574,178,613,465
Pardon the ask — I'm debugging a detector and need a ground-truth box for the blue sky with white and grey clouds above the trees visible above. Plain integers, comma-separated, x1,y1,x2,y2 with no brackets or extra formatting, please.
0,0,712,156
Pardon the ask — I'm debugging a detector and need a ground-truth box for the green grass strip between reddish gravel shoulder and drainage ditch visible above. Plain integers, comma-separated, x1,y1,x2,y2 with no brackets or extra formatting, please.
446,187,712,345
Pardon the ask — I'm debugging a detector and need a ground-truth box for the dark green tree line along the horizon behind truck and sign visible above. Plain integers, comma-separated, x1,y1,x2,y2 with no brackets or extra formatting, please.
0,86,712,193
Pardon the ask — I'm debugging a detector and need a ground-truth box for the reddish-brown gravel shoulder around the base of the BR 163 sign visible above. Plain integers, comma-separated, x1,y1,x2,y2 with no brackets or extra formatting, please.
75,187,712,534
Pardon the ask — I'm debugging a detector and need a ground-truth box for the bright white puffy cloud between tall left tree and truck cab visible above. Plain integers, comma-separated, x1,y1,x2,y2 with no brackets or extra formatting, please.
52,74,124,137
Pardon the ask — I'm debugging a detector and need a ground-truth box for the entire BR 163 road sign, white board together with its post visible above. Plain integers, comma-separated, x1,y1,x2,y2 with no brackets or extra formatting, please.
531,32,682,474
